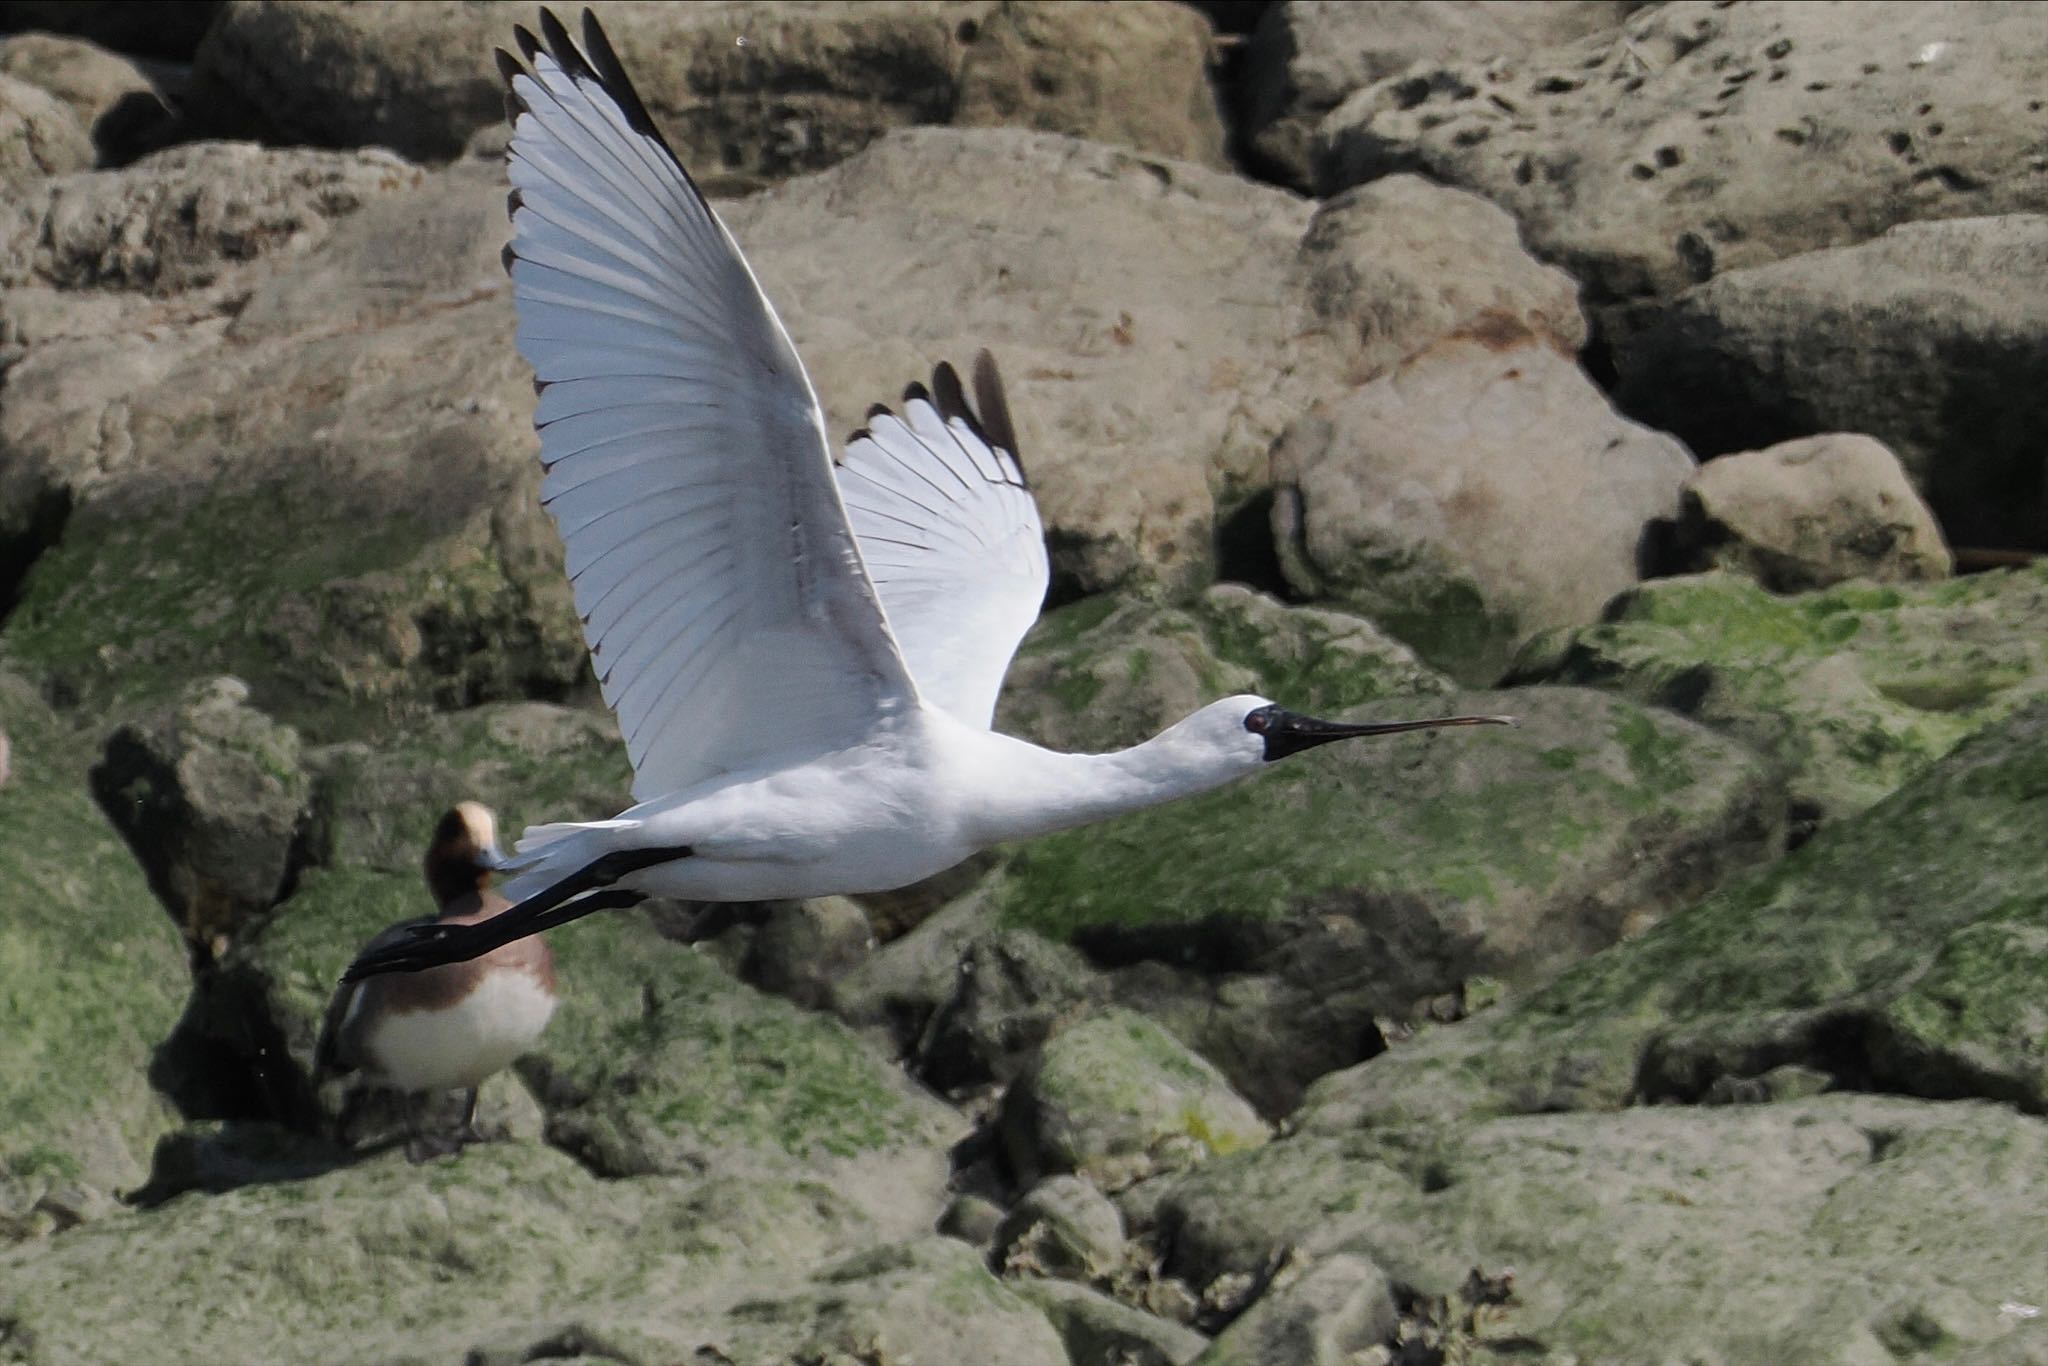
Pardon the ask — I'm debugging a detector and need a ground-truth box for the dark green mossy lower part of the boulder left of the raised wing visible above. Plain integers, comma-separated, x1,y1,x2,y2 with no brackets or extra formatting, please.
4,487,586,735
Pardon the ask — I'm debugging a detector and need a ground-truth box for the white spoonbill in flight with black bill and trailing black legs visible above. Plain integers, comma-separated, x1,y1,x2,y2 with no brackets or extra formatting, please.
348,10,1505,979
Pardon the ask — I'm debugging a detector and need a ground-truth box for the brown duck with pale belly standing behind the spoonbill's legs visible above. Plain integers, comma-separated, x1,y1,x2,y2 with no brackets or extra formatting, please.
313,801,555,1161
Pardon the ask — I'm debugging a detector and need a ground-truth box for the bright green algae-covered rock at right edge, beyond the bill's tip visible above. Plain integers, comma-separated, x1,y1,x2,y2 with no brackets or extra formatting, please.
1513,565,2048,819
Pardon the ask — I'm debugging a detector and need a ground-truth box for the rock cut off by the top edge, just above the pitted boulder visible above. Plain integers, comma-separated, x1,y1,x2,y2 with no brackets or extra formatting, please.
1239,0,1628,190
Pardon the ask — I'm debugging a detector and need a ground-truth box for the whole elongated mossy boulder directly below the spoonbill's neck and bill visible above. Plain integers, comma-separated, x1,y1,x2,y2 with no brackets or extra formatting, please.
997,688,1776,993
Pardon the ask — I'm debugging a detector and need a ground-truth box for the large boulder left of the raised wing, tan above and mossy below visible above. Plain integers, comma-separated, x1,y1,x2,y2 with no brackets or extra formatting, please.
0,154,588,729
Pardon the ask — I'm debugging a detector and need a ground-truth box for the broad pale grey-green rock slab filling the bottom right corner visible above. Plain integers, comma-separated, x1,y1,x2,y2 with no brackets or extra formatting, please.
1161,1097,2048,1362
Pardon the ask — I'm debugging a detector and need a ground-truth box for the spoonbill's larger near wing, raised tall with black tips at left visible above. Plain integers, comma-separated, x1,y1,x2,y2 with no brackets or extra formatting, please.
498,10,918,801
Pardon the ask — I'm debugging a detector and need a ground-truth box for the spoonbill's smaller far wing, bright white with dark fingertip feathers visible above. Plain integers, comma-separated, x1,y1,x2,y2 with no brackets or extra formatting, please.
840,352,1047,727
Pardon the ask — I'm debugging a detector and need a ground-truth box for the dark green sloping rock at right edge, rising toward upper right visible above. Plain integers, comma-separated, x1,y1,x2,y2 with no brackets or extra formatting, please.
1303,702,2048,1130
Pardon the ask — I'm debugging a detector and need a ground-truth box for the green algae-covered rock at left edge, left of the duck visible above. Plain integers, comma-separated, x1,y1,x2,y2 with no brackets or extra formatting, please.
0,672,188,1236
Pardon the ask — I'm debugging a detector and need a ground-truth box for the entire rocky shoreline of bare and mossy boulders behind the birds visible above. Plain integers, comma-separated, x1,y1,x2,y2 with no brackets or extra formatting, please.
0,0,2048,1366
